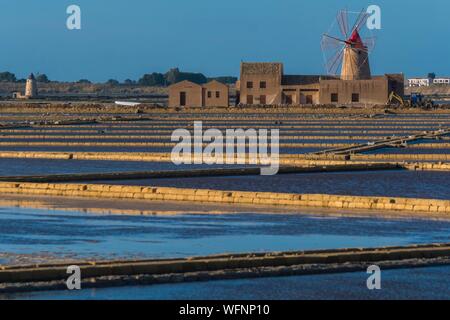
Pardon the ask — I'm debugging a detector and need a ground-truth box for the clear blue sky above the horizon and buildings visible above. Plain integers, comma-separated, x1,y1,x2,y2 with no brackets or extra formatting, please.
0,0,450,81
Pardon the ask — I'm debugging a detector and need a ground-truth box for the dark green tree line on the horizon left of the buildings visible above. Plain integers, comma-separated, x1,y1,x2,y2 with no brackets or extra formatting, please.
0,68,237,87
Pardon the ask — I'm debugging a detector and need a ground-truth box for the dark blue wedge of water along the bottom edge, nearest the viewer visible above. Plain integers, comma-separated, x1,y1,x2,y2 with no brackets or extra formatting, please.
7,266,450,300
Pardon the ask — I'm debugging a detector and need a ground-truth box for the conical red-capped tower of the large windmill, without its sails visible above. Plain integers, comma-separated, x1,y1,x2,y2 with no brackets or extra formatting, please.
341,30,371,80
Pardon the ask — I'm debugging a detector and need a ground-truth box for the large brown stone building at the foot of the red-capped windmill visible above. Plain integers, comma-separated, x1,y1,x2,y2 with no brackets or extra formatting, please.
236,62,404,105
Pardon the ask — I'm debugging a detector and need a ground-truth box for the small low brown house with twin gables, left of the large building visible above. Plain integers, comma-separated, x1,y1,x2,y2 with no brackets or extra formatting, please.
169,80,230,107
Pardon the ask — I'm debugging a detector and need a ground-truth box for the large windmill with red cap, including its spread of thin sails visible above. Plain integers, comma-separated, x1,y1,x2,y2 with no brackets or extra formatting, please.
321,10,375,80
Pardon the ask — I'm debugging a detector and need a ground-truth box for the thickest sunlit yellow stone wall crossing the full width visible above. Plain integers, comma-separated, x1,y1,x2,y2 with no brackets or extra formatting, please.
0,182,450,217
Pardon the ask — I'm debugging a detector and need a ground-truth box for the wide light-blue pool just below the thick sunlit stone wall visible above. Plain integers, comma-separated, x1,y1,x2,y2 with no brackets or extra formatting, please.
0,208,450,263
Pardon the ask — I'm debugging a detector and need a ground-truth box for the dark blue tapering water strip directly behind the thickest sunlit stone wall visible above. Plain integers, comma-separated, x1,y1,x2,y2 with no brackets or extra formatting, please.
94,170,450,200
